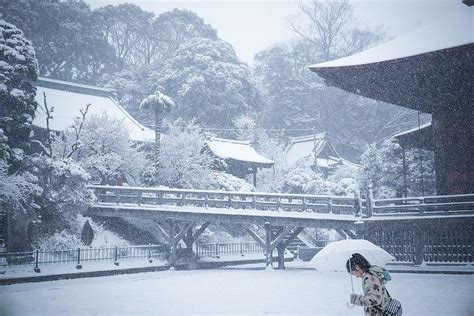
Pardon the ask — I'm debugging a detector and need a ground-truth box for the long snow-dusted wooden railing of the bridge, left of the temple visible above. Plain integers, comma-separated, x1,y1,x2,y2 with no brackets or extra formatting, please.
89,185,355,214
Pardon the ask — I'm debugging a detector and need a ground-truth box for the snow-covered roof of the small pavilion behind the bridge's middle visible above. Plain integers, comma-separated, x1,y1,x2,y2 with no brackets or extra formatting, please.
206,137,275,167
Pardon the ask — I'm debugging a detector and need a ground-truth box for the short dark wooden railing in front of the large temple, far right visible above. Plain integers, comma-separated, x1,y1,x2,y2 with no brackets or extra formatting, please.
367,194,474,216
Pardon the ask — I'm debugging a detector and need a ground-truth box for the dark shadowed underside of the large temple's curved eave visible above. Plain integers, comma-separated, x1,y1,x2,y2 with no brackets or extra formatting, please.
310,43,474,113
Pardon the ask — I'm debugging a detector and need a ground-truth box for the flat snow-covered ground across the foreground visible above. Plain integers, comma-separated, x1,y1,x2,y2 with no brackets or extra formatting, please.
0,262,474,316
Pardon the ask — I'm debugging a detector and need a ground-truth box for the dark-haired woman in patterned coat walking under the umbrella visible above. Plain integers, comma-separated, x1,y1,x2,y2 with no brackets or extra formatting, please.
346,253,402,316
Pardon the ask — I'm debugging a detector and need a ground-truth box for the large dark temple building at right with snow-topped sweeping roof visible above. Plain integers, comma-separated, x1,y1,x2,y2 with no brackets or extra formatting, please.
310,6,474,195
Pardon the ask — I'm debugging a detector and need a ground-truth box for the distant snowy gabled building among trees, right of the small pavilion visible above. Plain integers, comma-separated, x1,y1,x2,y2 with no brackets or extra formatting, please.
286,132,360,175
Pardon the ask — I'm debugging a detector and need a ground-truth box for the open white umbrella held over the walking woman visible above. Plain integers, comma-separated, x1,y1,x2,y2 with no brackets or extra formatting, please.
308,239,395,272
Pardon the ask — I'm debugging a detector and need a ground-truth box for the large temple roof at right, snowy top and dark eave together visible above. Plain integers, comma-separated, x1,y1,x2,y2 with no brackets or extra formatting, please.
309,3,474,113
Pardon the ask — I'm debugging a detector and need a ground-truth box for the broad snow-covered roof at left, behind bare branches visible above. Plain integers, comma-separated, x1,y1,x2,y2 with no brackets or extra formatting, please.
33,78,155,142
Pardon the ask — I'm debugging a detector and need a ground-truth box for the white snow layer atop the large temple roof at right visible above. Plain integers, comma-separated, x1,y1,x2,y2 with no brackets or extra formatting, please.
309,7,474,69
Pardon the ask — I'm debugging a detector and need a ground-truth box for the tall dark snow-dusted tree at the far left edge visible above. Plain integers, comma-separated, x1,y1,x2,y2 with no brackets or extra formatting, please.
0,19,40,251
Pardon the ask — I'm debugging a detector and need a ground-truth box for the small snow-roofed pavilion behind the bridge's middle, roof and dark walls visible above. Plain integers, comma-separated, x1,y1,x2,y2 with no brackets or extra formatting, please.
205,137,275,186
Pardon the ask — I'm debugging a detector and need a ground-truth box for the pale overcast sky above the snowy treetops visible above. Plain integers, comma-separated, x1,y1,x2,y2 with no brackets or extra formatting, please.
86,0,474,63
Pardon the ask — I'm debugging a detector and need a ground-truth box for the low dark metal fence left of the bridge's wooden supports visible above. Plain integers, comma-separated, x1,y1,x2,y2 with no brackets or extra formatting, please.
0,245,168,268
